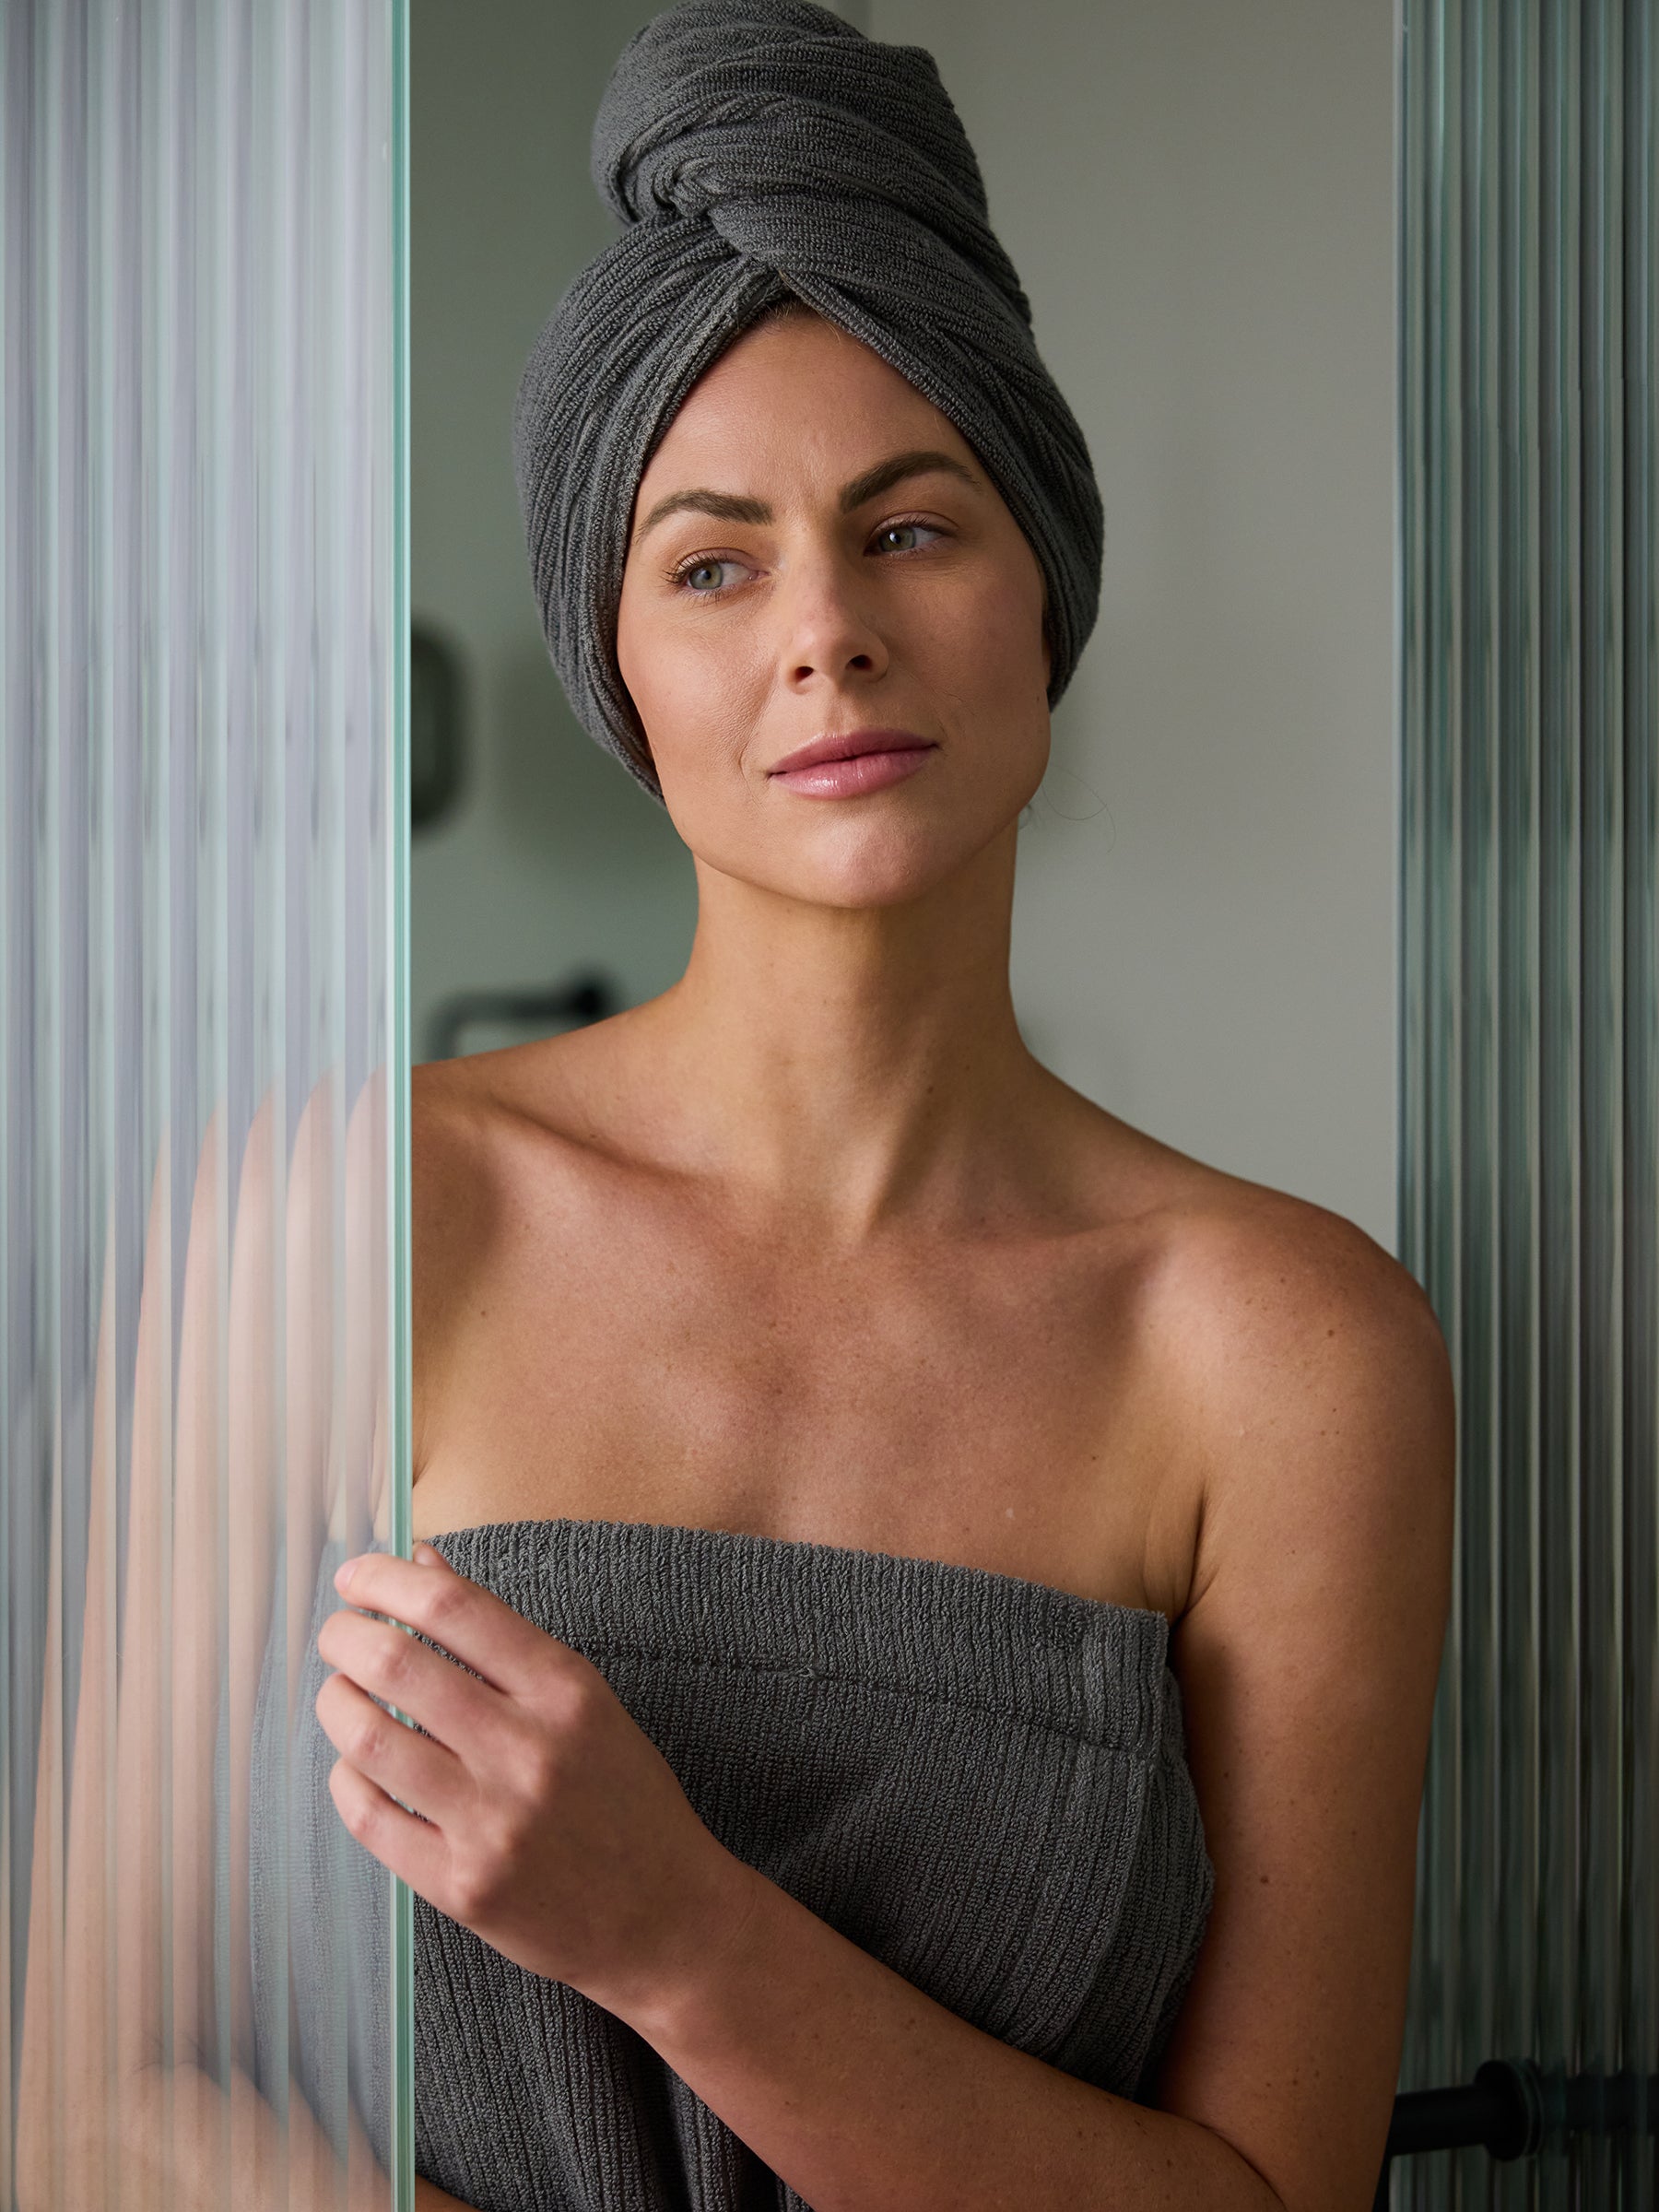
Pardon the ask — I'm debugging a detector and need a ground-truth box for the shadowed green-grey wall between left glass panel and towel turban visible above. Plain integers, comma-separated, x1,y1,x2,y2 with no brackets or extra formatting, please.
409,0,695,1057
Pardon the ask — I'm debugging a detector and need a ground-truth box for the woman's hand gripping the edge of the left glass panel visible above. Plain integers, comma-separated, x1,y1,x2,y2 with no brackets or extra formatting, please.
316,1544,761,2018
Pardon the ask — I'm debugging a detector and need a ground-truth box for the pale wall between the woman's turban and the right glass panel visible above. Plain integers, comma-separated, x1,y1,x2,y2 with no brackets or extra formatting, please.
874,0,1395,1250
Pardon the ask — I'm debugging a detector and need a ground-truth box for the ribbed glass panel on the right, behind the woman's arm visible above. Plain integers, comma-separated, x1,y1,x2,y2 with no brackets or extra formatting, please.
1392,0,1659,2212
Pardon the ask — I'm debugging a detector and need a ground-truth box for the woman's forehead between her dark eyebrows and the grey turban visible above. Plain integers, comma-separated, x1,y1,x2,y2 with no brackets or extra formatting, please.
635,316,978,513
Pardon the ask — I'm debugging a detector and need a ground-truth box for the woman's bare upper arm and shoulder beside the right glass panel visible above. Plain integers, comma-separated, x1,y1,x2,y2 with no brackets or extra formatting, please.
1157,1207,1455,2212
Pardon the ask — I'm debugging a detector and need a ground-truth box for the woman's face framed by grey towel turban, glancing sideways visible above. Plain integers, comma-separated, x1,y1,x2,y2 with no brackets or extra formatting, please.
618,316,1049,907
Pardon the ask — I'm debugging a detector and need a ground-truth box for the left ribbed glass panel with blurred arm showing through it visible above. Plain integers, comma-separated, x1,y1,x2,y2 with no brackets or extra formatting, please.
0,0,414,2212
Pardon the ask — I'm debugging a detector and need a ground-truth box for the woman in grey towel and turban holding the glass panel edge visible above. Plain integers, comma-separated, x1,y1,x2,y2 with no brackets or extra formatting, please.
316,0,1453,2212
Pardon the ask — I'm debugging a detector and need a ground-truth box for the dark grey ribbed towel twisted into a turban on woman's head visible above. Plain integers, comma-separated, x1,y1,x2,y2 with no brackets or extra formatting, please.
513,0,1101,798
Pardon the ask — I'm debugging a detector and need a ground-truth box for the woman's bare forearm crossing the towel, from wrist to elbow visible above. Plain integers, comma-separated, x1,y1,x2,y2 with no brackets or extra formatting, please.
621,1860,1283,2212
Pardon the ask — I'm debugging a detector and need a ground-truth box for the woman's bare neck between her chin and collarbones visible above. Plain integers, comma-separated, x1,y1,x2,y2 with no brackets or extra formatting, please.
619,825,1053,1241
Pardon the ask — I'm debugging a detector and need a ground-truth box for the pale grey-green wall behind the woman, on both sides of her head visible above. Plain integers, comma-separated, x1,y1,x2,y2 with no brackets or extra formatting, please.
411,0,1395,1250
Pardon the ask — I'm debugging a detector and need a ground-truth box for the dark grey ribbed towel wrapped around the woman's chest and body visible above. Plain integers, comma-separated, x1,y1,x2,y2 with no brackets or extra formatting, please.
253,1520,1215,2212
